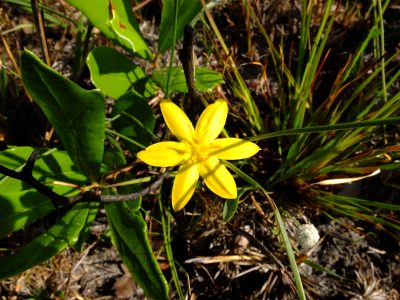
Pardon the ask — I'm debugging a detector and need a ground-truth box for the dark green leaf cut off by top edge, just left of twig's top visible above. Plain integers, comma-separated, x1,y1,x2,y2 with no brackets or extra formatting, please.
158,0,202,53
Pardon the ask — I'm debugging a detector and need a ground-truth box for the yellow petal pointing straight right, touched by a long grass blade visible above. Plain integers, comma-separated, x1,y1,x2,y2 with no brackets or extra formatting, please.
209,138,260,160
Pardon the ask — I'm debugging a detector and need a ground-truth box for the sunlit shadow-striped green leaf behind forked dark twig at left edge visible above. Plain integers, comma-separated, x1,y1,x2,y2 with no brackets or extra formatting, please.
0,147,86,238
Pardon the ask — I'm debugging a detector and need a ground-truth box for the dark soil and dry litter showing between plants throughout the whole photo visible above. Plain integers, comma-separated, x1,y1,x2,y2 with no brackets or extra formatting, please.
0,1,400,300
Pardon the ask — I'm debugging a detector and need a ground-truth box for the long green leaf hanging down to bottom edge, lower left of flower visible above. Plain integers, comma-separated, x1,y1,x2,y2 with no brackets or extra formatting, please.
106,202,168,300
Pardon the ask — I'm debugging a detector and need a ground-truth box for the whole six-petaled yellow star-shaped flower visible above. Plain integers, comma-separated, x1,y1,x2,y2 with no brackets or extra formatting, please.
137,99,260,211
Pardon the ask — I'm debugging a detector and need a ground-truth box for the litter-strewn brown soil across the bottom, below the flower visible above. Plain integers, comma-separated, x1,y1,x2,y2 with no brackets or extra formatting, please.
0,195,400,300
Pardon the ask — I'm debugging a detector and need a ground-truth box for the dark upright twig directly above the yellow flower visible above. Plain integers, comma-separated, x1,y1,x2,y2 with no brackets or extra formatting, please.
179,25,202,103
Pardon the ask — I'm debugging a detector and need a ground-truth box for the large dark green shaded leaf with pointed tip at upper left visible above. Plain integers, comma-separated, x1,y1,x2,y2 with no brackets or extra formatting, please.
21,50,105,182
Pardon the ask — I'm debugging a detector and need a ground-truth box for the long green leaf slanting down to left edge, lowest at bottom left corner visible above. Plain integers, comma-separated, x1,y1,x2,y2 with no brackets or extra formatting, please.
0,202,90,279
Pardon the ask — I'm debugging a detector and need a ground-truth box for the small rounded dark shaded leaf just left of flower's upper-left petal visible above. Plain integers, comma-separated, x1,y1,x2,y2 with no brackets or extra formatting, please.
112,93,155,153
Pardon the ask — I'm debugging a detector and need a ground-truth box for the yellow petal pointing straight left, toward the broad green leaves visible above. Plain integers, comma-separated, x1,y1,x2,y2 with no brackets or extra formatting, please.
137,142,190,167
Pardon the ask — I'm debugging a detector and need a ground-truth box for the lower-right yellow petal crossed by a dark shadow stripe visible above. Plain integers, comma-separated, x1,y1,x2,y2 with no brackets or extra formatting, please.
198,157,237,199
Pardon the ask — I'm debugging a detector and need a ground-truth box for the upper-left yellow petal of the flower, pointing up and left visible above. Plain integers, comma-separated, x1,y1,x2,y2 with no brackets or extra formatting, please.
160,99,194,141
